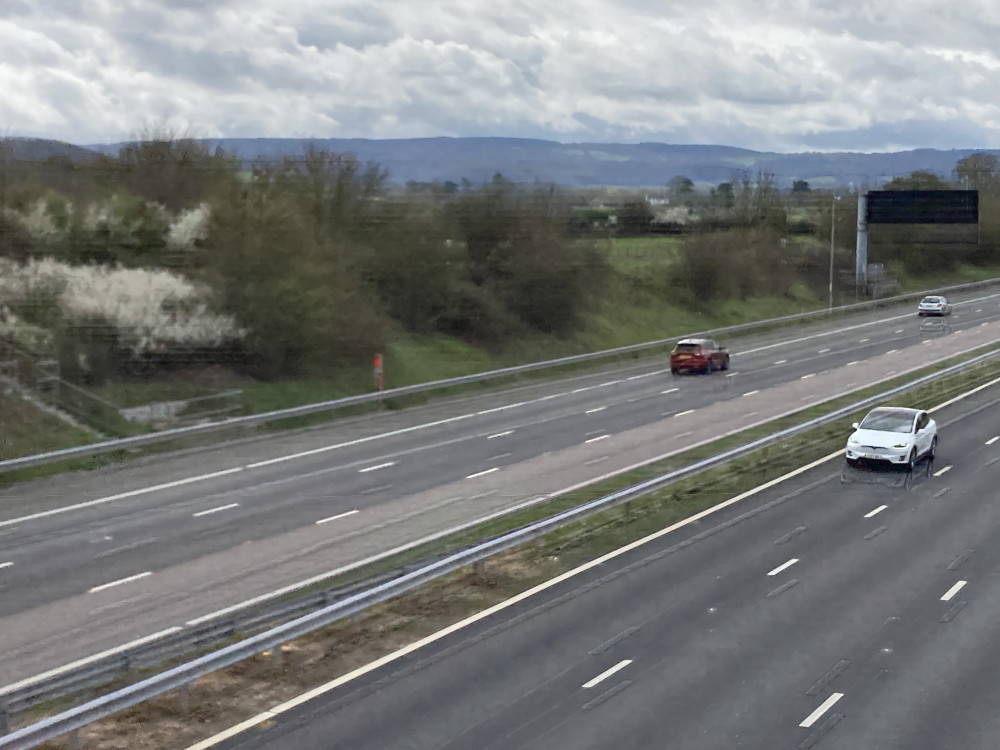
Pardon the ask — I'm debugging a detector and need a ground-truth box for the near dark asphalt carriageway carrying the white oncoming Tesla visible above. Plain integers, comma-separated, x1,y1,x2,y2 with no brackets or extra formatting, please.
215,370,1000,750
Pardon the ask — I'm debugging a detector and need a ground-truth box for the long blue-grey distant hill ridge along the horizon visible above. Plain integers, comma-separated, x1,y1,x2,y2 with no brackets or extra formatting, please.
76,138,1000,188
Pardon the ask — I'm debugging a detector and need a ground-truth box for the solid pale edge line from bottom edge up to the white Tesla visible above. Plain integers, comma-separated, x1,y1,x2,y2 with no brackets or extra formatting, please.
187,450,843,750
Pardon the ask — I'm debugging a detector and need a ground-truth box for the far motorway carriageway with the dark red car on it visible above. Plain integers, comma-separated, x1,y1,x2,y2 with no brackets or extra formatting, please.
0,292,1000,685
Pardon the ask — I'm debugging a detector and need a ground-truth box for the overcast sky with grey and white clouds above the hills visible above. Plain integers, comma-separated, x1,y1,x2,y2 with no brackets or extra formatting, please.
0,0,1000,151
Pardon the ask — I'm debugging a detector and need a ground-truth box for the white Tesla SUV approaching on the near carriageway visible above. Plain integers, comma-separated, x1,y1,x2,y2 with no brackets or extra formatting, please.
845,406,937,471
